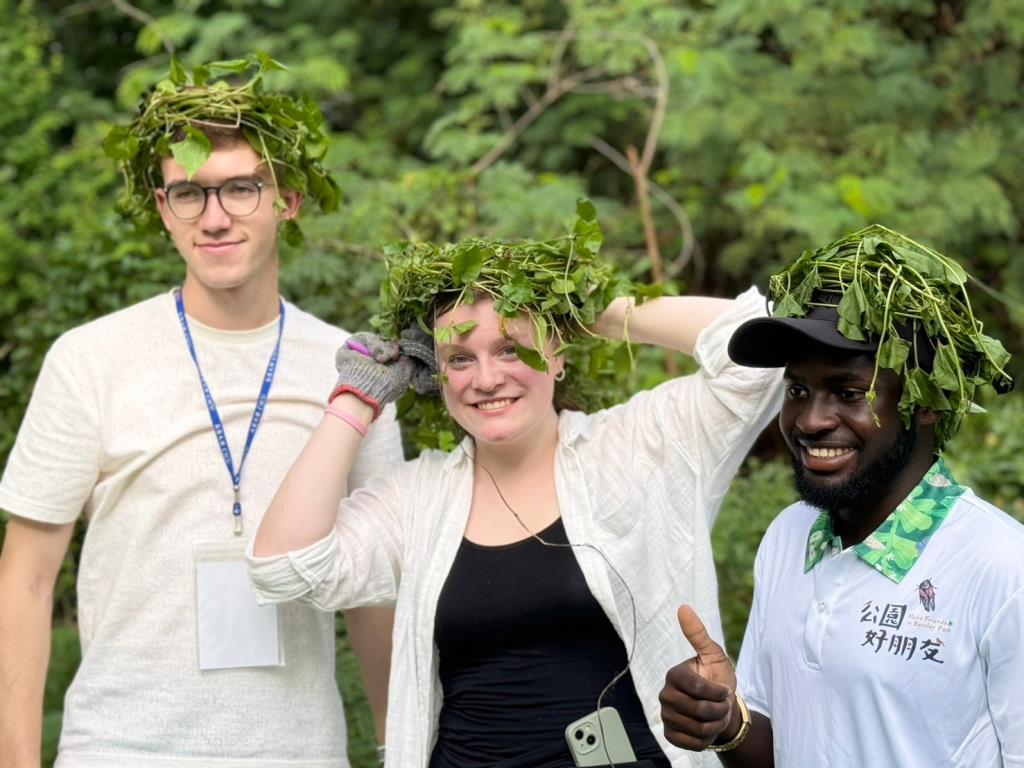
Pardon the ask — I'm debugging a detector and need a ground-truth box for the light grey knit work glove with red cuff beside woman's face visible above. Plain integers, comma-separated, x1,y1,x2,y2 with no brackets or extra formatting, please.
328,332,416,419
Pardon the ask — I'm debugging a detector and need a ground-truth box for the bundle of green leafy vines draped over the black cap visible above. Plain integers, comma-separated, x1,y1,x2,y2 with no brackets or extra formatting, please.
768,224,1013,447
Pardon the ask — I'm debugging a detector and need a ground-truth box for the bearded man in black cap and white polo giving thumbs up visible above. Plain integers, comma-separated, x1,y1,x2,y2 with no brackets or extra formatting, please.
660,226,1024,768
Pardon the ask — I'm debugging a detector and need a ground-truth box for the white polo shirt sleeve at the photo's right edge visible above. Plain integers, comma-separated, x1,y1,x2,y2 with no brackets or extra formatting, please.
979,587,1024,768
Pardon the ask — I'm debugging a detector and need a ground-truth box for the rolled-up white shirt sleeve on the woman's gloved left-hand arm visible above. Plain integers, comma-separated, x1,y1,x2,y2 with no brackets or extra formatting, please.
246,468,402,610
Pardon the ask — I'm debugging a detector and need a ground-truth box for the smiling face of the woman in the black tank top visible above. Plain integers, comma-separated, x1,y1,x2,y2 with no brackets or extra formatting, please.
434,298,563,444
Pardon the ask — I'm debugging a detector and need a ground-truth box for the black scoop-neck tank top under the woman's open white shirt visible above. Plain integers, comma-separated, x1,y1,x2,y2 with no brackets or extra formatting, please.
430,519,669,768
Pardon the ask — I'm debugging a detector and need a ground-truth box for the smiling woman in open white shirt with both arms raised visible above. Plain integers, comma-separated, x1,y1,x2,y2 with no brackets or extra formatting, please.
250,218,779,768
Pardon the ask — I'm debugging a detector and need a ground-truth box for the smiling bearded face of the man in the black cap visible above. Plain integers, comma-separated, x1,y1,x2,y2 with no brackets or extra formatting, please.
779,353,916,520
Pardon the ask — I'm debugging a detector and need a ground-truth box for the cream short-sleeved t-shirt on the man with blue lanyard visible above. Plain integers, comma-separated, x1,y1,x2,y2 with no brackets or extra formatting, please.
0,293,401,768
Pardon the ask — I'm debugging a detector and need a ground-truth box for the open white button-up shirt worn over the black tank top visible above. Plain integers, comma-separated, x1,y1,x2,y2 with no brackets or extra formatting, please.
250,289,781,768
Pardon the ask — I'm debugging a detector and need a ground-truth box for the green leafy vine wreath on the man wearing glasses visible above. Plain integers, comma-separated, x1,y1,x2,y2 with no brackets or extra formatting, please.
103,52,340,245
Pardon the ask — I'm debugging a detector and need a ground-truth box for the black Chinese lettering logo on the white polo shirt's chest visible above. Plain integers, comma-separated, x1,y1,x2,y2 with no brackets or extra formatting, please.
860,579,953,664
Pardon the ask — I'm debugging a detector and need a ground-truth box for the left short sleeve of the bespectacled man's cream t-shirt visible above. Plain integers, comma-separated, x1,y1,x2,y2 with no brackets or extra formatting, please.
0,336,101,523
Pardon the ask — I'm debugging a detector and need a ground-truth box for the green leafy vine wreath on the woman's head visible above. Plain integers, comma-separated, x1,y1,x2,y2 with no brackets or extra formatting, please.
373,200,634,449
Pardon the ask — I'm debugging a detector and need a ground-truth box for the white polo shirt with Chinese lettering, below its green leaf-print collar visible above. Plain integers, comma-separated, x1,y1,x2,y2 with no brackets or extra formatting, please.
737,490,1024,768
